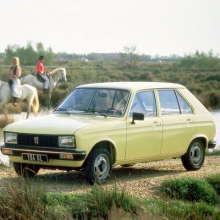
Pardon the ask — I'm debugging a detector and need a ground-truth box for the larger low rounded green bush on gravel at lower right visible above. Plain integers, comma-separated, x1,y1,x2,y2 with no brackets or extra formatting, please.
161,178,217,204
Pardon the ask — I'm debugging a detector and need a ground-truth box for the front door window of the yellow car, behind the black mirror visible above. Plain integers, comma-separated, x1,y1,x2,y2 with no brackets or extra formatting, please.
129,90,157,117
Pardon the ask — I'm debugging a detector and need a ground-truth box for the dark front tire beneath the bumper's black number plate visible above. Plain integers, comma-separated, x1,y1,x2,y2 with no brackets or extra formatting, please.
13,163,40,178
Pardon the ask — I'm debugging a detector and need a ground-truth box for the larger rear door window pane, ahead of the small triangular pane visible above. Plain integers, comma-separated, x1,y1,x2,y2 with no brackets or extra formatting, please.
158,90,180,115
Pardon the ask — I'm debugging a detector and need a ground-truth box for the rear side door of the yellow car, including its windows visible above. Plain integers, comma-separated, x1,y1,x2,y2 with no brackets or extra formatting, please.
158,90,195,155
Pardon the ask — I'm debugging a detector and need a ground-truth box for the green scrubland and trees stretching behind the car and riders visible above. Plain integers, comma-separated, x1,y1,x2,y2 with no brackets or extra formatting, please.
0,43,220,109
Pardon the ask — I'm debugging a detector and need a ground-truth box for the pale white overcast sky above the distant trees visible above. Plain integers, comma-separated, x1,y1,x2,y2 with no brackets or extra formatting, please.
0,0,220,56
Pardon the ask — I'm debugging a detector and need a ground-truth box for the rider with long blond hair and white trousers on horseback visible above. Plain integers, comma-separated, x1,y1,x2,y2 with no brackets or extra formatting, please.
8,57,22,106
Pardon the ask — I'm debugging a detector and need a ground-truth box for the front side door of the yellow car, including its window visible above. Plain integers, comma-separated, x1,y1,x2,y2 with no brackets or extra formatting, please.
126,90,162,160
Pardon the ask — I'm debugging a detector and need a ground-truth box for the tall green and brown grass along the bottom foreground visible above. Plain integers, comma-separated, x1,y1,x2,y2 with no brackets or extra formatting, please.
0,175,220,220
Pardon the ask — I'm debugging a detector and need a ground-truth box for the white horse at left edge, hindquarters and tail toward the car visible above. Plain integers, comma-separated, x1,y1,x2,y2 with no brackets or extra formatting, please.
0,81,39,119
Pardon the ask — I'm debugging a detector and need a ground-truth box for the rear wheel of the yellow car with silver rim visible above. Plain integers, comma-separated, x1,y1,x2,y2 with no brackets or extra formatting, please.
181,140,205,171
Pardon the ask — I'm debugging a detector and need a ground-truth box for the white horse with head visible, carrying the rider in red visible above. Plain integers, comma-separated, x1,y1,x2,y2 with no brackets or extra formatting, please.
20,68,67,109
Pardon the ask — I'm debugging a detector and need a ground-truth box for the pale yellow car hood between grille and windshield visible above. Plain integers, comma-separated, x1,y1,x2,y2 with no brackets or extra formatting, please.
4,114,109,134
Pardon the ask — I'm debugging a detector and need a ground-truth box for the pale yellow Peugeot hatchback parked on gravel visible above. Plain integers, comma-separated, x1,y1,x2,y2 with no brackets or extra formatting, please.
1,82,216,184
